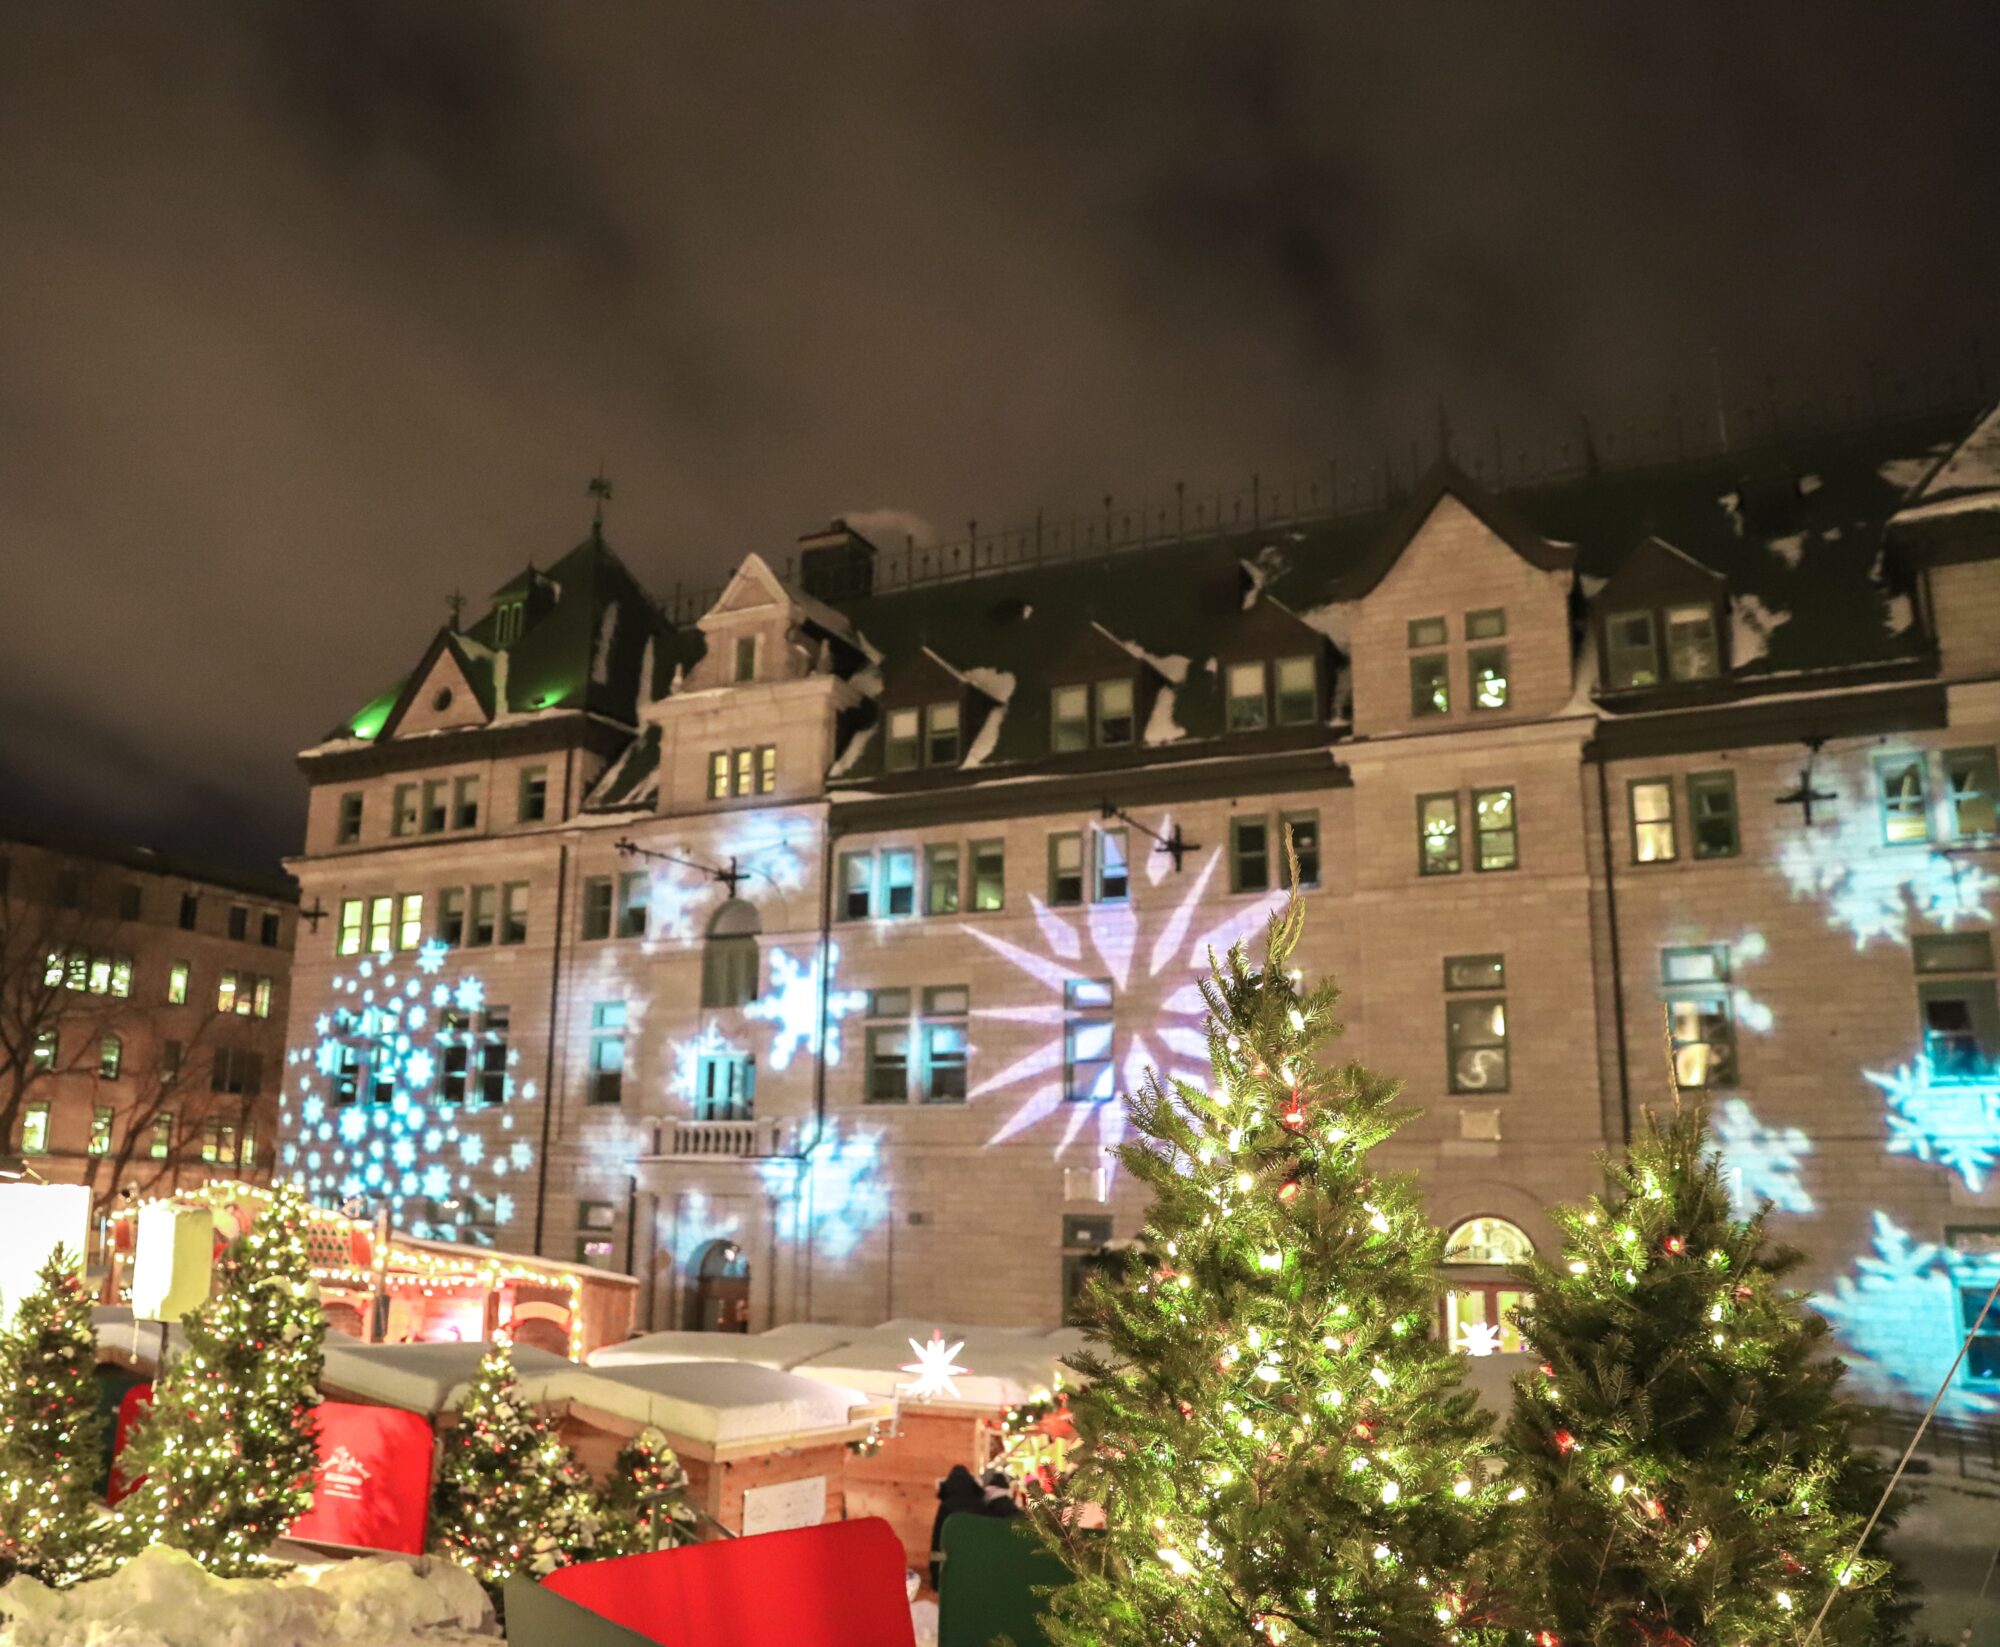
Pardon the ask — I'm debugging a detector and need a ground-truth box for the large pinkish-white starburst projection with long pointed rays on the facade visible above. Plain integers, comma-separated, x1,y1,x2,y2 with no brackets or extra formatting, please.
962,843,1284,1159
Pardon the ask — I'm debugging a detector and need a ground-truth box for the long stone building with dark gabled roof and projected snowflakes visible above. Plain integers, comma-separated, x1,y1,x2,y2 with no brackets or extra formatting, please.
286,399,2000,1409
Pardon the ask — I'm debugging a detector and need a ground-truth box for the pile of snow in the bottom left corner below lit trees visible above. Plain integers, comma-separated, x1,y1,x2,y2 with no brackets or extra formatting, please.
0,1545,494,1647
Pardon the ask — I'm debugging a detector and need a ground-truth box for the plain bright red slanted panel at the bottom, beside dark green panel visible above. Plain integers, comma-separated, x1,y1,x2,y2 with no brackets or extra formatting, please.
542,1515,916,1647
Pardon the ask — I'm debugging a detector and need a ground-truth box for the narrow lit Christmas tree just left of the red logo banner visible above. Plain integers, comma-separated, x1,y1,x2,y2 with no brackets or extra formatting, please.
118,1185,326,1575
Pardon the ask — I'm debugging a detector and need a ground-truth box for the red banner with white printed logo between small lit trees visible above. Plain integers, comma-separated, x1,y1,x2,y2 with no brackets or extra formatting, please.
290,1401,434,1555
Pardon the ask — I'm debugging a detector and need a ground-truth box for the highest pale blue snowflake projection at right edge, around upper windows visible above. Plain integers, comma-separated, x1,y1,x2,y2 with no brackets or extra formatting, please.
1778,770,2000,949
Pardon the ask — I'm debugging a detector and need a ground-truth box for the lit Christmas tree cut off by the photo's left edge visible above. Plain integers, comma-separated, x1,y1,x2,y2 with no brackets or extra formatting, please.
0,1247,108,1587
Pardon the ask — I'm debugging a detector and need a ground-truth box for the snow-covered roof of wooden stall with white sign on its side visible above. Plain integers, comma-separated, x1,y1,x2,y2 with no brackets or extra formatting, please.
550,1359,868,1447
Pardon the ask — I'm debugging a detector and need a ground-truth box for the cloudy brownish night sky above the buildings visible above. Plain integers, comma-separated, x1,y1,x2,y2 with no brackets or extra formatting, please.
0,0,2000,867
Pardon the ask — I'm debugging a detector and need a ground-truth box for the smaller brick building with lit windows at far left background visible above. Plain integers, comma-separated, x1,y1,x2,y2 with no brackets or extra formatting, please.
0,831,298,1217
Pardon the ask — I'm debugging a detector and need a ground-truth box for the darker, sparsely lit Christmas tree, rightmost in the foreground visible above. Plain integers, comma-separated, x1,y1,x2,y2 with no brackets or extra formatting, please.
1506,1097,1908,1647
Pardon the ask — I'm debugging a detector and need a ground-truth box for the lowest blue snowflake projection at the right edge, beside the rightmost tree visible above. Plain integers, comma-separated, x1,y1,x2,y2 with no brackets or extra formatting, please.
1812,1211,2000,1417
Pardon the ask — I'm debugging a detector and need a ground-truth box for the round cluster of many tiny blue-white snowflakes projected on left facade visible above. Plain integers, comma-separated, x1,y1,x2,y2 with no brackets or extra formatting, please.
278,941,534,1245
